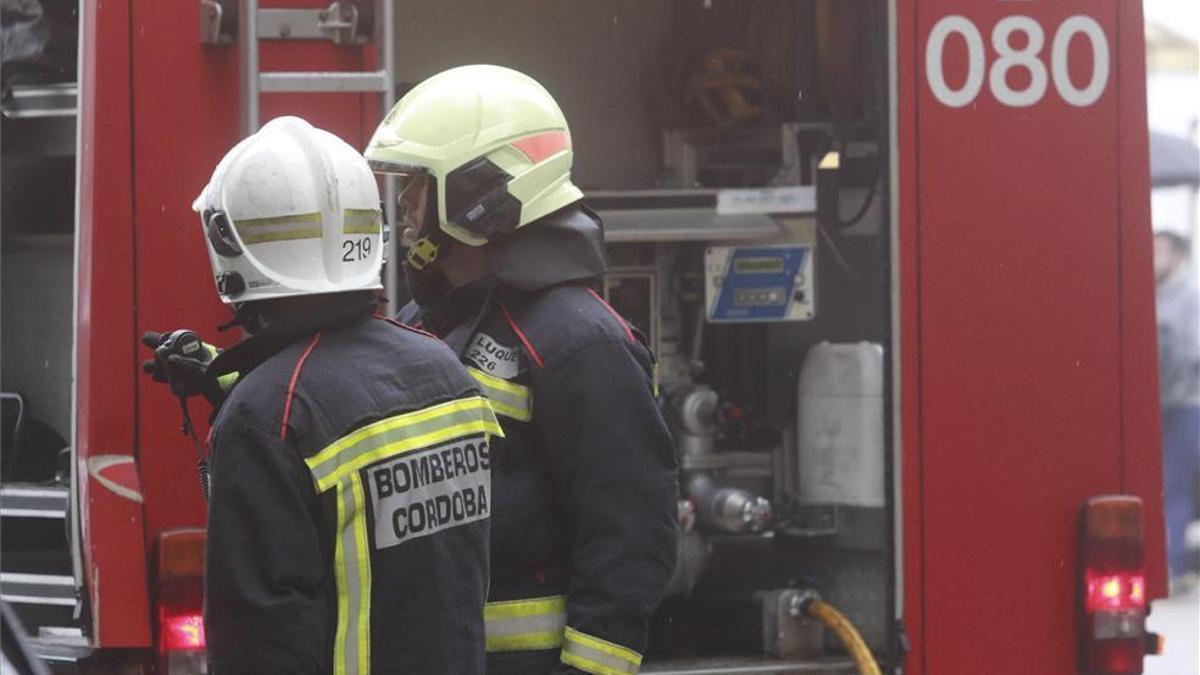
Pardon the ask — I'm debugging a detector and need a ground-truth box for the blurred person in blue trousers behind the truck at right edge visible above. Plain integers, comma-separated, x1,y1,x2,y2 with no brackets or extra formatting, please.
1154,232,1200,581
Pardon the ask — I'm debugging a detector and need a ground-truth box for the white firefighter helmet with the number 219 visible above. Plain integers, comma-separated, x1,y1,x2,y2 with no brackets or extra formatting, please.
192,117,383,303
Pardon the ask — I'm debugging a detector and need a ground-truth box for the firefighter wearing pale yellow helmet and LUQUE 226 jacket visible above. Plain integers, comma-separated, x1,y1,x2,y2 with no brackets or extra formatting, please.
365,66,678,675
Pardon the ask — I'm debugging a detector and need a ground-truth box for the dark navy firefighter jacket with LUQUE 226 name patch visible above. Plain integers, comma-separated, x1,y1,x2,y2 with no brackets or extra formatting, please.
401,207,678,675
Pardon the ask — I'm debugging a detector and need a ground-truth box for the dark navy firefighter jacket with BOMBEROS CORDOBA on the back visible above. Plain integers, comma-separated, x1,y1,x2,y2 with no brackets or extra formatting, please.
205,310,499,675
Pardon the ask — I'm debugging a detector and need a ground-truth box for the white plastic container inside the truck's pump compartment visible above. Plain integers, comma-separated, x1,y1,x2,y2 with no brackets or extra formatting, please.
796,342,884,507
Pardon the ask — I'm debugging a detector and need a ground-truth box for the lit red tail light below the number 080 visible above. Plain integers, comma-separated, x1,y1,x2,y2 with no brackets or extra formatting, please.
1079,495,1157,675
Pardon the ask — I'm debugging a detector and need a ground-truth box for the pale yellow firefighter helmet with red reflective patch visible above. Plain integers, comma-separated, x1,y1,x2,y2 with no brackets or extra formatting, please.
365,65,583,264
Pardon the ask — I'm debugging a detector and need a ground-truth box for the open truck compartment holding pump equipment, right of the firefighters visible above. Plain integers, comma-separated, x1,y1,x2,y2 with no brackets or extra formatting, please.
396,0,902,673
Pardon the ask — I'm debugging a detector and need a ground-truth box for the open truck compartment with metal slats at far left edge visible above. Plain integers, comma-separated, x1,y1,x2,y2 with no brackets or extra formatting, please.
0,0,78,648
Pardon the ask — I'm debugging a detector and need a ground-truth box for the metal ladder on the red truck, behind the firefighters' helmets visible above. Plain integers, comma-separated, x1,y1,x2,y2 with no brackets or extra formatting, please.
200,0,398,313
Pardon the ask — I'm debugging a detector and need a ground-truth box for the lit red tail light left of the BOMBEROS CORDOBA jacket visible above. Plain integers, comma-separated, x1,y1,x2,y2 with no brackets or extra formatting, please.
155,530,206,675
